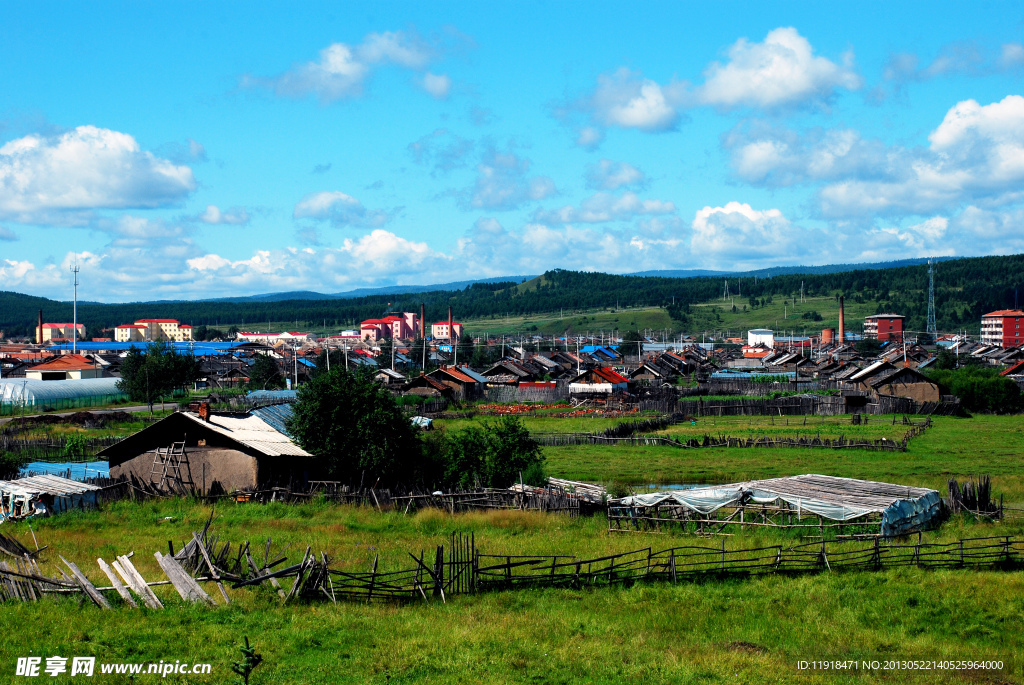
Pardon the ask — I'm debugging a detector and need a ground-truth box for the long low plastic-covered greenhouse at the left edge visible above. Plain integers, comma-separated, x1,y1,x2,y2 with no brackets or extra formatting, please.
0,378,128,416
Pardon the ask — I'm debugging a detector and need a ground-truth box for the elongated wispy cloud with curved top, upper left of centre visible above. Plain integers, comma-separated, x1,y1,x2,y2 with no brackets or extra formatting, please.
242,31,440,102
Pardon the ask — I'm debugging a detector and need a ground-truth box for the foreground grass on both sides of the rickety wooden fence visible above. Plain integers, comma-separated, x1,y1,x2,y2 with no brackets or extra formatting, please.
0,502,1024,685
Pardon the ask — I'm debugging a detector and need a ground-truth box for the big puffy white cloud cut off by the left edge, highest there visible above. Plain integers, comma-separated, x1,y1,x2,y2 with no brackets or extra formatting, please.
0,126,196,223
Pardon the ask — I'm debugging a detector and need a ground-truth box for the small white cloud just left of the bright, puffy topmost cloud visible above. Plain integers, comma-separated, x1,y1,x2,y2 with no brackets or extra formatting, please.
590,67,685,132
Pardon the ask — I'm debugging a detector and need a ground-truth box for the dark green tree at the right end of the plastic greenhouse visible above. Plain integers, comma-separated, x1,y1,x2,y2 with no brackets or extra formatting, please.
118,342,200,412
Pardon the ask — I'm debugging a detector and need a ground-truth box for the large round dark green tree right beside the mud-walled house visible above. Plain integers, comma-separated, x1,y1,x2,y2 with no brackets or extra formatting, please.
289,366,422,484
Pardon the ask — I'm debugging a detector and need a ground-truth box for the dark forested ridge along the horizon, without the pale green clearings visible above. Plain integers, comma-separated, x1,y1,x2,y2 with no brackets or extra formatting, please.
0,255,1024,336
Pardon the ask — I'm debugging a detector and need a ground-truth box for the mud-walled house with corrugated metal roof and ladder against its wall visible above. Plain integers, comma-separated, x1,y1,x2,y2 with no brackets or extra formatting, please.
98,403,318,494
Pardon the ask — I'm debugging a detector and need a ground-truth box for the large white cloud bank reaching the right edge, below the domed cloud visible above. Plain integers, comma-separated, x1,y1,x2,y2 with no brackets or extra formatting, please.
722,95,1024,219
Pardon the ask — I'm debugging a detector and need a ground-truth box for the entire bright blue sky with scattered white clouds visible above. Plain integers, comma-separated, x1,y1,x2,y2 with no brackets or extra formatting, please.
0,2,1024,301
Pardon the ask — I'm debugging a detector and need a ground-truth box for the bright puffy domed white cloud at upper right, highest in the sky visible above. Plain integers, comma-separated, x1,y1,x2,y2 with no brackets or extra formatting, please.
697,28,862,108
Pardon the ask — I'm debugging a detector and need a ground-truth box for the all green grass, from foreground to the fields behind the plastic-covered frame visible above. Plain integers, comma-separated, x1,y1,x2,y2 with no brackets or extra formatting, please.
0,409,1024,685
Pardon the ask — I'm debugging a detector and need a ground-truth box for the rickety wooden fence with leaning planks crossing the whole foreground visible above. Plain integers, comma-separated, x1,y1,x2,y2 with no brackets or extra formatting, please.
0,513,1024,609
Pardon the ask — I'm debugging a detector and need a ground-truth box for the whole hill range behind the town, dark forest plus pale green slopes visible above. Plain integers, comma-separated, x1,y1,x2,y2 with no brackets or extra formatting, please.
0,255,1024,336
